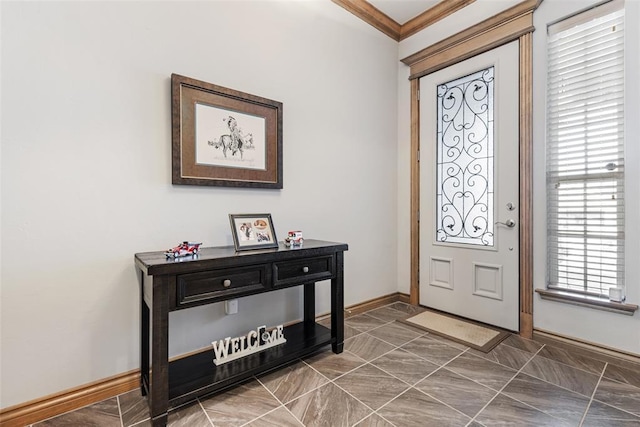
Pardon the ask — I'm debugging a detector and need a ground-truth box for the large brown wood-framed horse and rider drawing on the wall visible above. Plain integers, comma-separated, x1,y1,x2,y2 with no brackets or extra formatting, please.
171,74,282,189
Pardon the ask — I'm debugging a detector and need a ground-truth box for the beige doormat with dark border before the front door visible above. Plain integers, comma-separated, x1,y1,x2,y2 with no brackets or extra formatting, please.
398,311,511,353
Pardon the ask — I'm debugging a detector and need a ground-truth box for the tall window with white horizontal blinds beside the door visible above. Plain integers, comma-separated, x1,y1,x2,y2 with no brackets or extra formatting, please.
547,1,624,297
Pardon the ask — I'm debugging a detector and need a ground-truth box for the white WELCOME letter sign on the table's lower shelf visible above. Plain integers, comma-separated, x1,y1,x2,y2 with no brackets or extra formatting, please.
211,325,287,366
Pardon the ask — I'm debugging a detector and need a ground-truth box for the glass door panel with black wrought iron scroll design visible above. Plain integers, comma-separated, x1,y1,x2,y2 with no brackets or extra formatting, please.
436,66,494,246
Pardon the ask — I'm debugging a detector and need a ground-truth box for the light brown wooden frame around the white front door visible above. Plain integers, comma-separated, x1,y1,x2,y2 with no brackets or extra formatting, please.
402,0,542,338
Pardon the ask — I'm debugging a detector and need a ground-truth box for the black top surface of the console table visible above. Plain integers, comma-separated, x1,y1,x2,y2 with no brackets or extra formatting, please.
135,239,349,275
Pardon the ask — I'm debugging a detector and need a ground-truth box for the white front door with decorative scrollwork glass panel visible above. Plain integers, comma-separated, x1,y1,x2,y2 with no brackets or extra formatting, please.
419,41,519,331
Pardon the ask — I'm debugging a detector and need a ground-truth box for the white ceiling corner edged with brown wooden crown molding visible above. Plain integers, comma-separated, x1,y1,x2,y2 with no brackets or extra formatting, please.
332,0,476,41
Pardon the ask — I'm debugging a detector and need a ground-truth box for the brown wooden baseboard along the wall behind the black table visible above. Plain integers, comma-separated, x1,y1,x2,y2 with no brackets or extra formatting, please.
0,292,409,427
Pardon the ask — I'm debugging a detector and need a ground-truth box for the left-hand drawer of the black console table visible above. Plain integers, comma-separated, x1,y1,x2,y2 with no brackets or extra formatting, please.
176,265,270,307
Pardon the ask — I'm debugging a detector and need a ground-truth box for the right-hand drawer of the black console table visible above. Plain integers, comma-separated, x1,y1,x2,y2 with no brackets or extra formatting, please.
273,255,336,286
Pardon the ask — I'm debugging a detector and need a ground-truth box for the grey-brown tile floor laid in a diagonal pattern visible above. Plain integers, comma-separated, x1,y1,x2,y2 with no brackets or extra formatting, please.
33,303,640,427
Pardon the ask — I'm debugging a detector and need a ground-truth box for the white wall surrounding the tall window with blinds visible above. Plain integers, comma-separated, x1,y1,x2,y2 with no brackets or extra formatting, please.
533,0,640,354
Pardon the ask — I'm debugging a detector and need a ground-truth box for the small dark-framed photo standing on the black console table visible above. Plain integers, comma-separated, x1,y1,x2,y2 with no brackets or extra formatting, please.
229,214,278,251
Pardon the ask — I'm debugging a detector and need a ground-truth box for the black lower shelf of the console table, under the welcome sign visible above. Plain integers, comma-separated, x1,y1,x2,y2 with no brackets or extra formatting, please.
169,322,332,407
